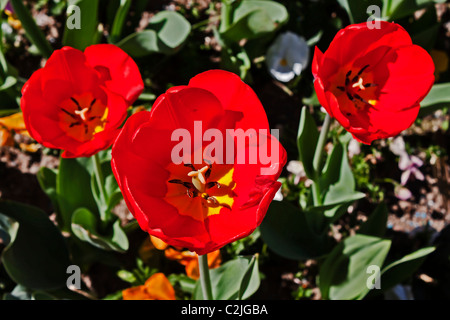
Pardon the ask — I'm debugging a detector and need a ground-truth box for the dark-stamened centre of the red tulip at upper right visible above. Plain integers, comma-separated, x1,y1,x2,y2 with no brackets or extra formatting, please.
335,65,377,116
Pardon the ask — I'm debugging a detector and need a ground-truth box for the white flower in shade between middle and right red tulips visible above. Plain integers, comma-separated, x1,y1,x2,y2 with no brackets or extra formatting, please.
266,31,309,82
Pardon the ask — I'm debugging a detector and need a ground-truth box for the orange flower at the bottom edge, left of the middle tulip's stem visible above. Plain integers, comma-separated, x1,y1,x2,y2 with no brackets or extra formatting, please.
122,272,175,300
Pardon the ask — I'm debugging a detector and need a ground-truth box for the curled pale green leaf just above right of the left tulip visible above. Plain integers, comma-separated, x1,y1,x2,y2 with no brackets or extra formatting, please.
117,11,191,57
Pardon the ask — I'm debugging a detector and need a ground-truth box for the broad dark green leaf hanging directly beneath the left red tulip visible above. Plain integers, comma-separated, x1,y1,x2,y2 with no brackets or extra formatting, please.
56,157,97,231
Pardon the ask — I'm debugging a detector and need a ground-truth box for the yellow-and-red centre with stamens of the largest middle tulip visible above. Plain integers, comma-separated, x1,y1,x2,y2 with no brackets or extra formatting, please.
165,163,236,221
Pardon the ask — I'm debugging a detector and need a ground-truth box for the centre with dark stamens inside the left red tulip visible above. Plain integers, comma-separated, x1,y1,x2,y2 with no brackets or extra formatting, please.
59,93,108,142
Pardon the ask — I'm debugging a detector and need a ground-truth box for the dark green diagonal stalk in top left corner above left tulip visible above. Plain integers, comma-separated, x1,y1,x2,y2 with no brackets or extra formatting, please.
10,0,53,58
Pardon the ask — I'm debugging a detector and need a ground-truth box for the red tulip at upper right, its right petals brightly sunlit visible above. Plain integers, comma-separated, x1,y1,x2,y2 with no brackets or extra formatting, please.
312,21,434,144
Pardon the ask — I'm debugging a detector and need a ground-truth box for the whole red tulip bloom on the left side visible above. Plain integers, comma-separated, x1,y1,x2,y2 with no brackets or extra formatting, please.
21,44,144,158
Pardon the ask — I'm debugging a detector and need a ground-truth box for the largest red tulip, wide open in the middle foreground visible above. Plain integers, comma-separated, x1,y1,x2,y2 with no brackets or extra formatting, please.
112,70,286,255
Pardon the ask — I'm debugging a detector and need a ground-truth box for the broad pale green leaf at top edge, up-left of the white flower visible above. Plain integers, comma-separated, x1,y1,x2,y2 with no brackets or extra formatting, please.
220,0,289,43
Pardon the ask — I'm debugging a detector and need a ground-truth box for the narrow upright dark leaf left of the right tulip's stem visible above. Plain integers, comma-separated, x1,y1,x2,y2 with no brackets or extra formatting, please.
297,107,319,178
